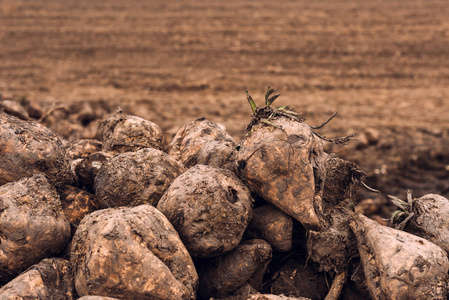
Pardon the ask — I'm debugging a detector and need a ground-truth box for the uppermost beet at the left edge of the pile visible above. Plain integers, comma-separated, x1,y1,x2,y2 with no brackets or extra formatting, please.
0,111,73,185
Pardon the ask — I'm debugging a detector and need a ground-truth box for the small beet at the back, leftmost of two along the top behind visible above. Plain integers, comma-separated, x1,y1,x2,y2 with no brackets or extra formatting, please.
98,109,165,153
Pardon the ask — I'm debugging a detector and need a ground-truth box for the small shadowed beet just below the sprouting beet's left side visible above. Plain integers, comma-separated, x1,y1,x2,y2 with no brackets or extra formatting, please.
248,204,293,252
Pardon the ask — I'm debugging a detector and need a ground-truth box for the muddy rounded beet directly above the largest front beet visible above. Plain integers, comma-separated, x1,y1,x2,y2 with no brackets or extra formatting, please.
94,148,185,208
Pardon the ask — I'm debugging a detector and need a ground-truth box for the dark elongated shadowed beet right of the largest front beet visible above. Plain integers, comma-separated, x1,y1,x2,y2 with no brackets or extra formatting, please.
198,240,272,298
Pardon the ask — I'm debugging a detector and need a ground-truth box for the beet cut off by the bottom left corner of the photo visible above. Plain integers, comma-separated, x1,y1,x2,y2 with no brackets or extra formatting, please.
0,258,75,300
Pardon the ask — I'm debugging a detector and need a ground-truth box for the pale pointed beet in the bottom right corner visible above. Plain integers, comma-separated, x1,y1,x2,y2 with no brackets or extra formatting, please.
350,214,449,299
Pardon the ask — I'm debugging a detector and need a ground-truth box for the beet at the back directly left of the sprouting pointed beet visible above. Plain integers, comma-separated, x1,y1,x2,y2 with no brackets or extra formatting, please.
168,118,237,170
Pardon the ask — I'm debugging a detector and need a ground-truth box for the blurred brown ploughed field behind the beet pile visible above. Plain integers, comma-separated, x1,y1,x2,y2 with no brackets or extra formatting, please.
0,0,449,205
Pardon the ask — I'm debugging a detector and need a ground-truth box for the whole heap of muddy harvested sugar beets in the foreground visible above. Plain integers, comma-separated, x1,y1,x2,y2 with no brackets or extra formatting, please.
0,88,449,300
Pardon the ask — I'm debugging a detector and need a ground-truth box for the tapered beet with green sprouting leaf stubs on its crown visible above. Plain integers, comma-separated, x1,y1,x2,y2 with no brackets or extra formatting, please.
237,117,325,230
